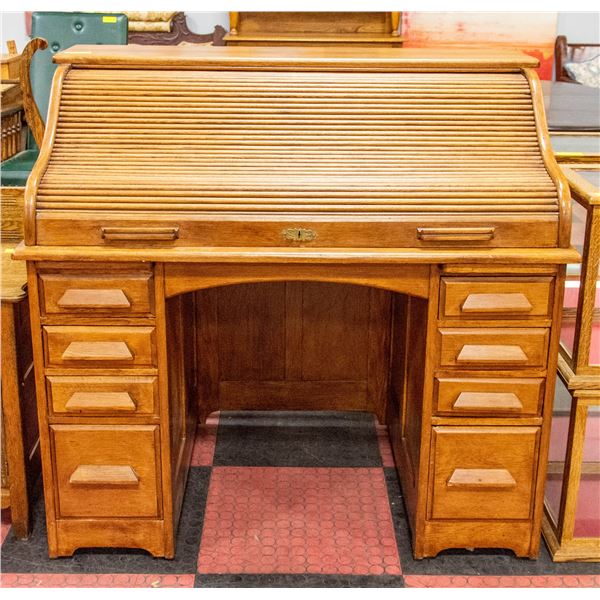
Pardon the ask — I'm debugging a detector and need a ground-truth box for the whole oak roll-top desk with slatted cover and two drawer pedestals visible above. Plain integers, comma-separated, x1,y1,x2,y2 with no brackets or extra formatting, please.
11,46,578,558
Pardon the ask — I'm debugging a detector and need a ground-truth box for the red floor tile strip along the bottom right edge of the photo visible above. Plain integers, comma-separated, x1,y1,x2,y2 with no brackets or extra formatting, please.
404,575,600,588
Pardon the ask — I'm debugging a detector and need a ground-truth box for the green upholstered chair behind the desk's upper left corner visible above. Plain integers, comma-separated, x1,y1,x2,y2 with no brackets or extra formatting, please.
0,12,128,186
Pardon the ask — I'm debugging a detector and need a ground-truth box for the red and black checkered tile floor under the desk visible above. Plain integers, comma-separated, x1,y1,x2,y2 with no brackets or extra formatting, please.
1,412,600,587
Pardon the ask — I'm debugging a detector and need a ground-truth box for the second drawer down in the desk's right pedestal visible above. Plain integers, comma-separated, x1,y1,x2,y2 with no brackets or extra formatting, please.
439,328,549,370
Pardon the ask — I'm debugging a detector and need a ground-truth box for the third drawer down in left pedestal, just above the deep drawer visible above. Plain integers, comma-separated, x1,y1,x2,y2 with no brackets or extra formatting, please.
46,376,158,416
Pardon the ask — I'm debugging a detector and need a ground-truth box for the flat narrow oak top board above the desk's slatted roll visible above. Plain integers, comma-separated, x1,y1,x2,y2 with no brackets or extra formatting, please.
54,44,539,70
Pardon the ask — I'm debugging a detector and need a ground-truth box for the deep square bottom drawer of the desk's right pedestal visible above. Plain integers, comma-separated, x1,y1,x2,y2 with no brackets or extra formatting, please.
430,427,540,520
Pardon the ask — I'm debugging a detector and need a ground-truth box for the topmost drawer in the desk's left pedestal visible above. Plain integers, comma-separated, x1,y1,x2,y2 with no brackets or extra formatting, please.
40,273,154,316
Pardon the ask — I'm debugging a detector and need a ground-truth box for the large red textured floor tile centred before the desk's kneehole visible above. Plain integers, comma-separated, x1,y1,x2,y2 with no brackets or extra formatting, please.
198,467,401,575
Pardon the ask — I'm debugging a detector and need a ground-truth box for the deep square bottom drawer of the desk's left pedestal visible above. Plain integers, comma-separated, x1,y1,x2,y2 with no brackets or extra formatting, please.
51,425,159,517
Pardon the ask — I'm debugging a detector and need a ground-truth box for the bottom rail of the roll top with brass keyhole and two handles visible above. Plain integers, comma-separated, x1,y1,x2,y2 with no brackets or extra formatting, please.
37,214,558,248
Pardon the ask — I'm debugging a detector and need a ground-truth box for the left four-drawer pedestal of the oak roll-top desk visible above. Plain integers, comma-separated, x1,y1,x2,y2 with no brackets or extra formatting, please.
29,263,196,558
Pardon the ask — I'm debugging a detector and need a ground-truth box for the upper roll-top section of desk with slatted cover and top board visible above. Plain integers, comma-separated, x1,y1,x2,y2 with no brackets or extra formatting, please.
26,46,570,248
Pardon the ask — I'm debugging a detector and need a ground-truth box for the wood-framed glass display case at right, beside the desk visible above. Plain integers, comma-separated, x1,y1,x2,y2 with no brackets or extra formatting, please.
543,163,600,561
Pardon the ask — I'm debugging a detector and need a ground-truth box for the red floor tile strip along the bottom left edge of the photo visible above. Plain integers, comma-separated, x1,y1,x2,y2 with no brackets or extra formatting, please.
0,573,194,588
